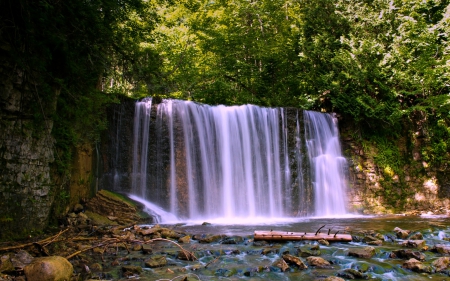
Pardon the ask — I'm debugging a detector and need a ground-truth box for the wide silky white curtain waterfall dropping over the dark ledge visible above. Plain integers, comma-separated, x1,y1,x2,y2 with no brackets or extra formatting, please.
112,98,346,220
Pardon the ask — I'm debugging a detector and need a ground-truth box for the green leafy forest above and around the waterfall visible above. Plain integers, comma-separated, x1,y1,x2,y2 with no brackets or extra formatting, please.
0,0,450,207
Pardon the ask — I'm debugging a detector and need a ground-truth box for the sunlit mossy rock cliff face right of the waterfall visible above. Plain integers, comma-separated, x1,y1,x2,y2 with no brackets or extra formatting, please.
340,114,450,214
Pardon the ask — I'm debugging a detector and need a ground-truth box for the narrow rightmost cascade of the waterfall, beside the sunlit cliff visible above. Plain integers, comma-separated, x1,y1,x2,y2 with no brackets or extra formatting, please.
304,111,347,217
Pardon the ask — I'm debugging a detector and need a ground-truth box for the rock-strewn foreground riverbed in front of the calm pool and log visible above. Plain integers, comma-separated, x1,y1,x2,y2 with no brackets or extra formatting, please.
0,219,450,281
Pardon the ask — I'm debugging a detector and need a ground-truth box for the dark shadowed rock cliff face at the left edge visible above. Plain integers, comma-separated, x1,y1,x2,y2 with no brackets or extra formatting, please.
0,64,57,238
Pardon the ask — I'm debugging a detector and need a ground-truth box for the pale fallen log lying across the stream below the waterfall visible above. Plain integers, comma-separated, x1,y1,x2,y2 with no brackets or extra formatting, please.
254,230,352,242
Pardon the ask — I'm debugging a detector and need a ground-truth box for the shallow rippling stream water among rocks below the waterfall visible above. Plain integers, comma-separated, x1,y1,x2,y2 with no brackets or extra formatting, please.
142,216,450,281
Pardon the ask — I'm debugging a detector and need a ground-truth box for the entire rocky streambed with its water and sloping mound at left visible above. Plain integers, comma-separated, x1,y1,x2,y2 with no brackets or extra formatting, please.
0,191,450,281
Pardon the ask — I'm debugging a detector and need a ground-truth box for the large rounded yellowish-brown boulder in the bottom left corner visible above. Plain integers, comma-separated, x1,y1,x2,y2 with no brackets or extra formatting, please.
24,256,73,281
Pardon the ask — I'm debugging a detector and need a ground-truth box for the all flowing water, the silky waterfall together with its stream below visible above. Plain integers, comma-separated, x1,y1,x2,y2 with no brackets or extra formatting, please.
102,99,450,280
